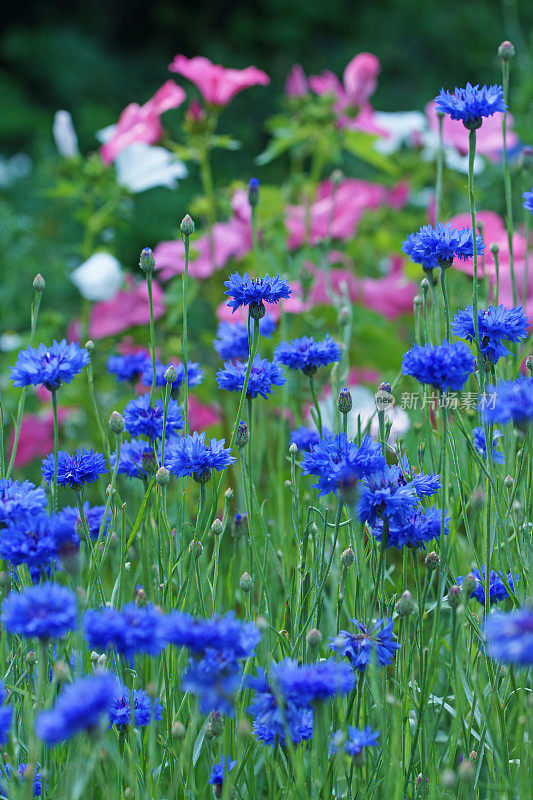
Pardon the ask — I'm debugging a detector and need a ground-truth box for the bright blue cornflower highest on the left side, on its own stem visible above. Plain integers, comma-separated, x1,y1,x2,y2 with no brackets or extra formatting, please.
11,339,89,391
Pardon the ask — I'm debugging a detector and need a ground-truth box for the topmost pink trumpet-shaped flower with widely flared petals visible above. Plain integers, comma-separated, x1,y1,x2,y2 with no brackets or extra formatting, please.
169,55,270,106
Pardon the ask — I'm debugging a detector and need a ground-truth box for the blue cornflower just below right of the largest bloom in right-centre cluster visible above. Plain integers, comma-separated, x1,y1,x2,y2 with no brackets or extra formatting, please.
357,466,418,525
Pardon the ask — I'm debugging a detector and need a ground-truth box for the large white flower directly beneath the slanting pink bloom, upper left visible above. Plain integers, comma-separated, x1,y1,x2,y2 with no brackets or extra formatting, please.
115,142,187,193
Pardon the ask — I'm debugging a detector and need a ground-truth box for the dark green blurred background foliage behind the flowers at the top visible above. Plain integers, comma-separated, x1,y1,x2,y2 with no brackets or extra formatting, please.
0,0,533,330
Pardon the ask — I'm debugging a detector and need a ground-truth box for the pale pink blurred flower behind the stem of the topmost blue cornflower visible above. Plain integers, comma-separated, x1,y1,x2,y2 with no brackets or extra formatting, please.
425,100,518,161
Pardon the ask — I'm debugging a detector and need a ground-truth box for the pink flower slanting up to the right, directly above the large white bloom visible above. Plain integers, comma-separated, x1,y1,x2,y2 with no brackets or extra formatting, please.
100,80,185,164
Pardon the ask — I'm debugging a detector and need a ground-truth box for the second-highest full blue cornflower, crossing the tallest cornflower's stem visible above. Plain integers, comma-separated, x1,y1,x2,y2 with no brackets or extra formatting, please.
402,222,484,270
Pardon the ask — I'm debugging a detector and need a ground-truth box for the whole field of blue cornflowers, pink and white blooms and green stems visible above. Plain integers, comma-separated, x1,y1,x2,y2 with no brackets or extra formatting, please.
0,28,533,800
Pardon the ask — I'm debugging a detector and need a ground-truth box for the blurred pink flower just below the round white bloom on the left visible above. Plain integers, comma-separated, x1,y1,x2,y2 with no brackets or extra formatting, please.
89,276,165,339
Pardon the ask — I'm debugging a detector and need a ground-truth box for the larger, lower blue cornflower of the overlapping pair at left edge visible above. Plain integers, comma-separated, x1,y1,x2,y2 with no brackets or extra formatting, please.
0,512,57,571
